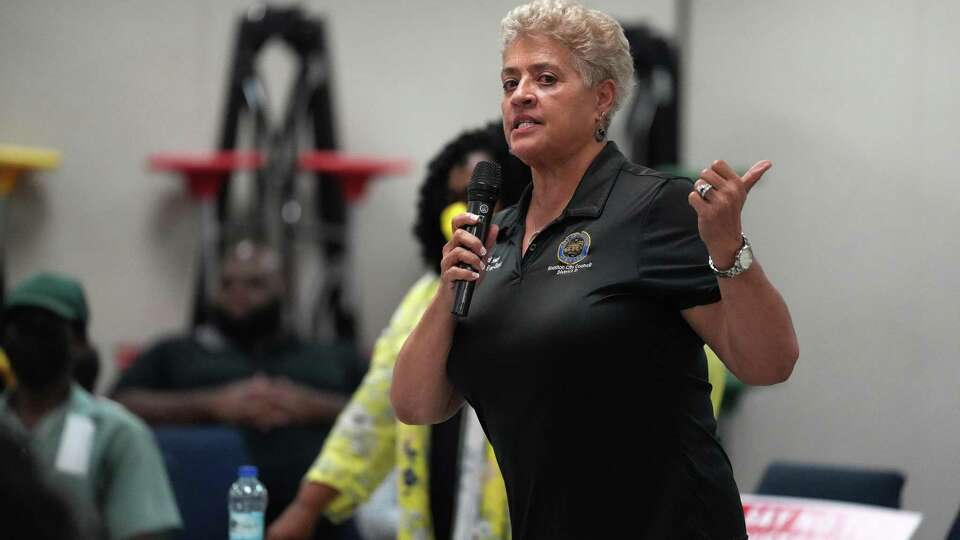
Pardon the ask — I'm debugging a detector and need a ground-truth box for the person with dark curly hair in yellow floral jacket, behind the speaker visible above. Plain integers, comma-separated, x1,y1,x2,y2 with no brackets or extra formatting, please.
268,122,530,540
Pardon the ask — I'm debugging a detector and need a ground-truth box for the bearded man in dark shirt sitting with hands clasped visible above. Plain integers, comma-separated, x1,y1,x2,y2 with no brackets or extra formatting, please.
114,239,360,534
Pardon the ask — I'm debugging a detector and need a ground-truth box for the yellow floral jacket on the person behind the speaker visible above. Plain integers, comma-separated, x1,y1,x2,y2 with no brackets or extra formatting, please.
306,273,510,540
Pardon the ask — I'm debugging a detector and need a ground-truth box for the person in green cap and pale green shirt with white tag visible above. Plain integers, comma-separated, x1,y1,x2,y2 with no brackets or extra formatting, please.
0,274,181,540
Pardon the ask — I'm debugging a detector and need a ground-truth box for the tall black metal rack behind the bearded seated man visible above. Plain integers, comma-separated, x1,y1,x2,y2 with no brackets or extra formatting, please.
193,5,356,342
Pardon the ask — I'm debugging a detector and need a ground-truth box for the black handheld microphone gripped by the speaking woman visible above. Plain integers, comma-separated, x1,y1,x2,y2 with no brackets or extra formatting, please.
452,161,502,317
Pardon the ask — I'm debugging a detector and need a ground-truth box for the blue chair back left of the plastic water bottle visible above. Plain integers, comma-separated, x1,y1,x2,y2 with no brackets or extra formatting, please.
154,427,251,540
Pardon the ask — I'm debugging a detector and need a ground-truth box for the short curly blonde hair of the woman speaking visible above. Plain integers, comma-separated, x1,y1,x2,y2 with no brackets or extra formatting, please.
500,0,633,125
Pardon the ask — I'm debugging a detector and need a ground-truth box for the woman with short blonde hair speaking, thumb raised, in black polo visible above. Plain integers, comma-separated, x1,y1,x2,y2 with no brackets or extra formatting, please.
391,1,799,540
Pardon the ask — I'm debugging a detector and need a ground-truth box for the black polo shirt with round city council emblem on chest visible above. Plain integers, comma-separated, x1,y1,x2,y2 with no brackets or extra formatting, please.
447,143,746,540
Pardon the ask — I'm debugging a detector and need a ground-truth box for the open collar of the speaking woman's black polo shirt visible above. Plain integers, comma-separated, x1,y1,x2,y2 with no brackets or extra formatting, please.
500,141,627,235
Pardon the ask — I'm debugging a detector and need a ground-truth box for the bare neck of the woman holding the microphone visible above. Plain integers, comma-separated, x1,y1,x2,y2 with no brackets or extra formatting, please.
526,142,604,234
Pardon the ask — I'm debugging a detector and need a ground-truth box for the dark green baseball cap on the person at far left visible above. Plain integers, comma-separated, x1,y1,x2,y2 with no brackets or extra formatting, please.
5,272,90,323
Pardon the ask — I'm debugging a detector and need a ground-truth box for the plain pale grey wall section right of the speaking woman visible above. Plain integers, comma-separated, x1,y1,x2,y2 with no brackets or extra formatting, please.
687,0,960,540
